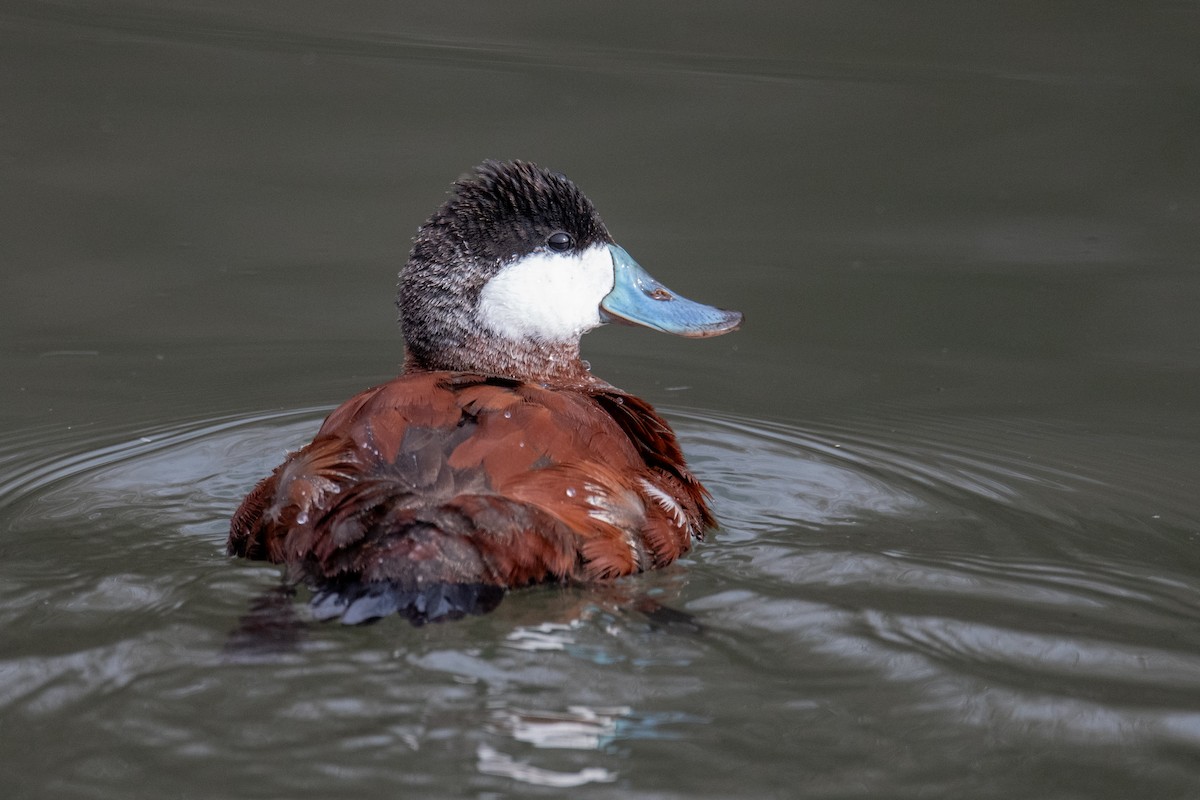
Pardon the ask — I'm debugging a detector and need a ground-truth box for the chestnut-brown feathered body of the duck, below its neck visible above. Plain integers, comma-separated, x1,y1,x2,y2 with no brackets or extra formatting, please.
228,372,713,618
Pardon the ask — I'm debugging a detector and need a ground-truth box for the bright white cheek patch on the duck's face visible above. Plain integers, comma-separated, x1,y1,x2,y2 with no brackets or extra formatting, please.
479,245,613,342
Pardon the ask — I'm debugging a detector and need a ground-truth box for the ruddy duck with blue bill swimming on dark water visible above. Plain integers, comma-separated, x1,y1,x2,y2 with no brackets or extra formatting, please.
227,161,743,624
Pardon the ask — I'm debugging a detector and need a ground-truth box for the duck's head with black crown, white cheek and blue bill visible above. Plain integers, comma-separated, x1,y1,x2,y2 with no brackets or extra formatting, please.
396,161,742,380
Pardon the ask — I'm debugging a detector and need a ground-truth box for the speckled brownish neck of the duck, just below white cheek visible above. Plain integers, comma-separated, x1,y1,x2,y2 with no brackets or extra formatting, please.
404,337,606,389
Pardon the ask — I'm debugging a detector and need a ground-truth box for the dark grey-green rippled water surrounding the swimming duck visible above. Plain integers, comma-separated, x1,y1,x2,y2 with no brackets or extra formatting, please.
0,2,1200,799
